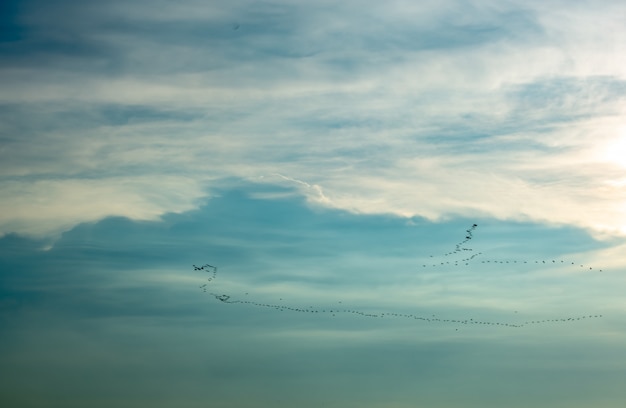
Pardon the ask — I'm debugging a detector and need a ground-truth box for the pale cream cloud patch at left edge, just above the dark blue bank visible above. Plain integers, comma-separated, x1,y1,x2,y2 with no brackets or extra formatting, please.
0,176,205,236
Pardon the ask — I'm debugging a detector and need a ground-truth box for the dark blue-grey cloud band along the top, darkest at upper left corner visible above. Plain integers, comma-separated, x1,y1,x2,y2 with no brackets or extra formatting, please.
2,1,541,78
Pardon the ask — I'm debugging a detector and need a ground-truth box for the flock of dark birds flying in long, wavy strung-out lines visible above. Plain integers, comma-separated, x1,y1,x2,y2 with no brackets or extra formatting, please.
193,224,602,330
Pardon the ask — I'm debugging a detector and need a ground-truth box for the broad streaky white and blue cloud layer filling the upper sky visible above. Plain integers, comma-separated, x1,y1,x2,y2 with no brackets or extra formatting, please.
0,2,626,239
